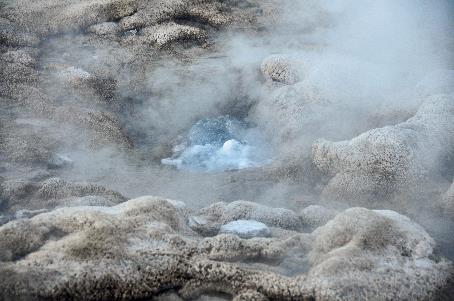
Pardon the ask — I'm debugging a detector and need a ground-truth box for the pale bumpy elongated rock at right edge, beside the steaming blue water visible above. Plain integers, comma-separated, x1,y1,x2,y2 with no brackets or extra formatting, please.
313,94,454,199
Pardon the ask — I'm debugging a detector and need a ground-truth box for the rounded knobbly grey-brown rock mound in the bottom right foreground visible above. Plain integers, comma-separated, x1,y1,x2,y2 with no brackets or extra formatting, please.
309,208,449,300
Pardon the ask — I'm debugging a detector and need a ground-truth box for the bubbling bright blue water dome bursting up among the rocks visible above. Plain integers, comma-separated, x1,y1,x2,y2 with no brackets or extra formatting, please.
161,115,269,171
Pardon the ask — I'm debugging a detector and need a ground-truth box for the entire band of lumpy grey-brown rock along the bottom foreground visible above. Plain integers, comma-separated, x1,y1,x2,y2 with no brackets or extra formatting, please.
0,197,453,300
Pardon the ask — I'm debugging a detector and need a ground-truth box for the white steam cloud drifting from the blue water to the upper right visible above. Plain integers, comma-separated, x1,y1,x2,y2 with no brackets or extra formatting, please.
46,0,452,195
